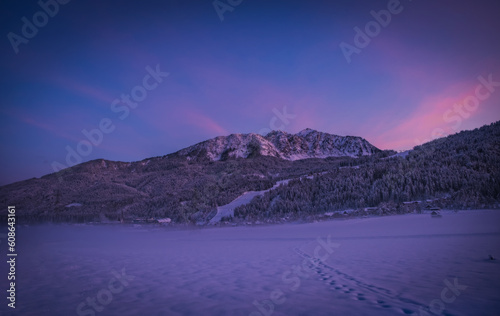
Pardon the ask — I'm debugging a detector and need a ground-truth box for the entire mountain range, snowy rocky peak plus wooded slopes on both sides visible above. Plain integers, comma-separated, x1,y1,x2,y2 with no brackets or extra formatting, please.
0,122,500,223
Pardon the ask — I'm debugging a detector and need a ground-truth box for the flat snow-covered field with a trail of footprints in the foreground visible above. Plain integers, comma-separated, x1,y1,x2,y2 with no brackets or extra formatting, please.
0,210,500,316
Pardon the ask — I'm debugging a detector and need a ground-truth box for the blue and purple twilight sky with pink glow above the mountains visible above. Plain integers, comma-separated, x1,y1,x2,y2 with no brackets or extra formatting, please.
0,0,500,185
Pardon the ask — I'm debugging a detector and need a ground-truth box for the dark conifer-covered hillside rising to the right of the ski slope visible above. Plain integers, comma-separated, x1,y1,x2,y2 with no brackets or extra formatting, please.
235,122,500,219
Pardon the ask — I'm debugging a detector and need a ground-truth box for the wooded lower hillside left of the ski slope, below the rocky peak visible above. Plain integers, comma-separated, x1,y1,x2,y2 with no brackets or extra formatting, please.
0,153,368,222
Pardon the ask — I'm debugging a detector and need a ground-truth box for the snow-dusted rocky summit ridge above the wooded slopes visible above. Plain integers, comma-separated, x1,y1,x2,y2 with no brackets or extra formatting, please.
176,128,380,160
